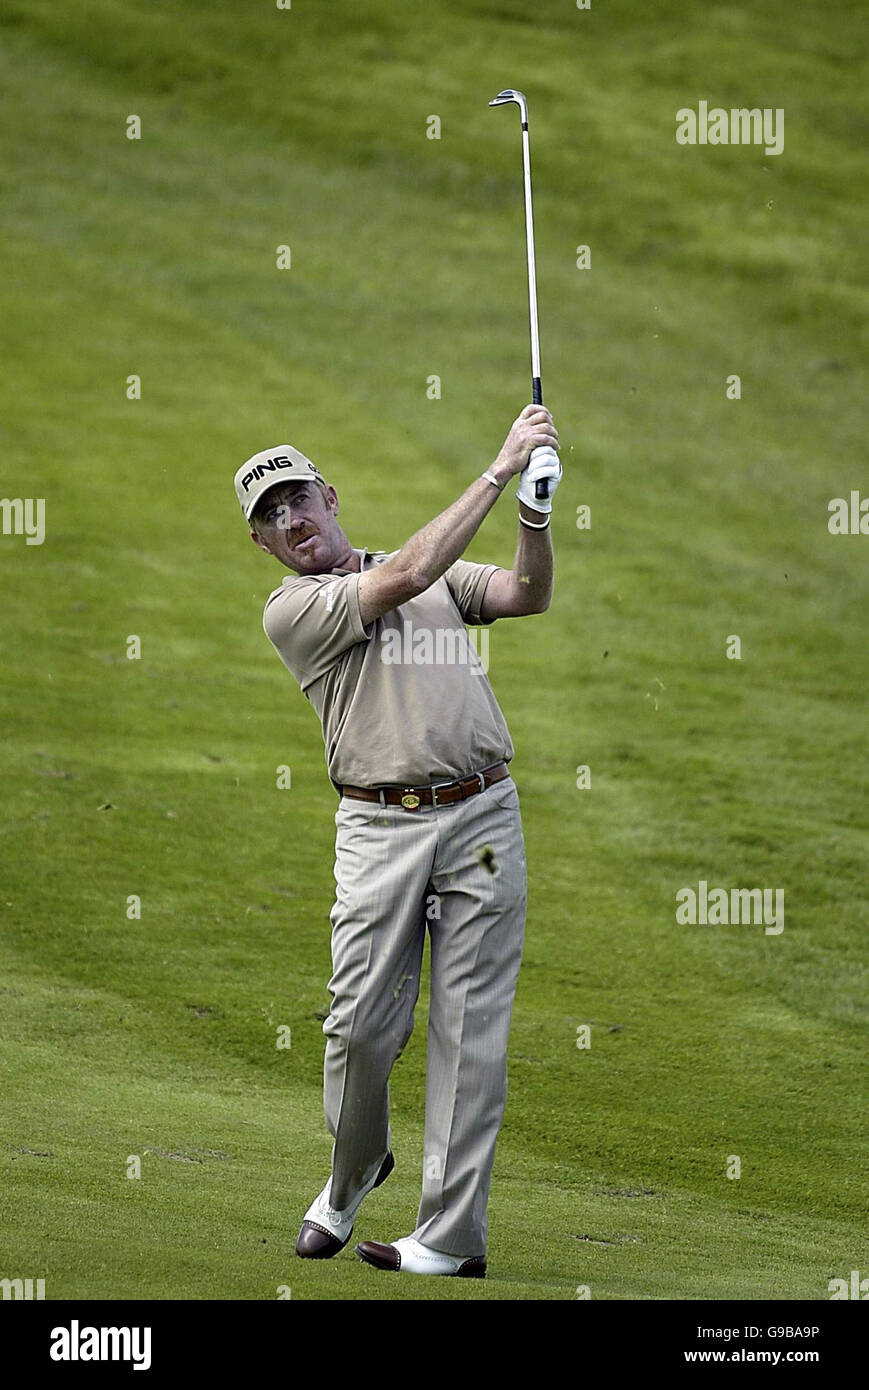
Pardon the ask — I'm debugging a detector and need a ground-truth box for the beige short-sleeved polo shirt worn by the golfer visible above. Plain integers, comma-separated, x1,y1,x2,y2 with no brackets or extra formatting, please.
263,549,513,787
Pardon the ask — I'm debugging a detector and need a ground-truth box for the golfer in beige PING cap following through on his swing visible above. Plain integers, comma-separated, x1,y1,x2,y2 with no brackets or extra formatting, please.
235,404,562,1279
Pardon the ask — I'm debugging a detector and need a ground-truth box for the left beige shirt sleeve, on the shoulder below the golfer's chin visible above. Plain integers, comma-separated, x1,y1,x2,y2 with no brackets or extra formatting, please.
263,573,374,689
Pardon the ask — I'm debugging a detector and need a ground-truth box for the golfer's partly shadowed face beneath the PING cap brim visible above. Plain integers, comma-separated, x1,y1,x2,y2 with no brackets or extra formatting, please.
250,480,340,574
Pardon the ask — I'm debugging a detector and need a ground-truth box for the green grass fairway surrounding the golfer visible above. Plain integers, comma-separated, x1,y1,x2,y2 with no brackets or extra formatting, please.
0,0,869,1301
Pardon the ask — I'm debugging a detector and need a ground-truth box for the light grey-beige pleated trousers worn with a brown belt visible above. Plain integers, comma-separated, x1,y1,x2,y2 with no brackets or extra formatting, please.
323,777,526,1258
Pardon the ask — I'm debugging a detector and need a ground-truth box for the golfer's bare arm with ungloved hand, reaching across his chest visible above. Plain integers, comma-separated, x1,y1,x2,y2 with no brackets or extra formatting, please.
359,404,558,627
